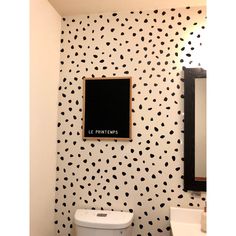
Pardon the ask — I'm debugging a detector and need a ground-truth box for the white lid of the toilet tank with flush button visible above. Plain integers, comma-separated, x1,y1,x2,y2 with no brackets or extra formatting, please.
74,209,134,229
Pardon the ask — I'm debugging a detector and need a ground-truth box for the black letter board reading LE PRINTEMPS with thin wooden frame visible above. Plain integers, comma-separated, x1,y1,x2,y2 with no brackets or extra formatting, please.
83,77,132,141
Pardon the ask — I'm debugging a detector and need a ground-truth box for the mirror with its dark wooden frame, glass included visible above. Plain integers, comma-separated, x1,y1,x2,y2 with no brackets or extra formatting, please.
183,67,206,191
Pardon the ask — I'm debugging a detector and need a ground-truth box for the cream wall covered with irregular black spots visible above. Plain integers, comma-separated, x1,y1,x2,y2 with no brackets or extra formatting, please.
55,7,206,236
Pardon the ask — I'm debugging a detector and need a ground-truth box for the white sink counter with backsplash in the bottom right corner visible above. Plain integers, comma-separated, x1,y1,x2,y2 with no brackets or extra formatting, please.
170,207,206,236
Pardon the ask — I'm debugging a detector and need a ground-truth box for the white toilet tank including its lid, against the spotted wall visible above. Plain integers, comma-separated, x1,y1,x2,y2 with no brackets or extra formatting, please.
74,209,134,236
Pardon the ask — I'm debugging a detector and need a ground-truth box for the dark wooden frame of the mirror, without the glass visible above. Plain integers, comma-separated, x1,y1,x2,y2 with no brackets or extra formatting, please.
183,67,207,191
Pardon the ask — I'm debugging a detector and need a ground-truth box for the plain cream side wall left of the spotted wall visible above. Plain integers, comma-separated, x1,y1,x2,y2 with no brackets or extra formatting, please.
30,0,61,236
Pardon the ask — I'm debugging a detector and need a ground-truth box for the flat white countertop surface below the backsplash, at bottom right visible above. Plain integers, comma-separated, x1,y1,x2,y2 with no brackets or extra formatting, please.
170,221,206,236
